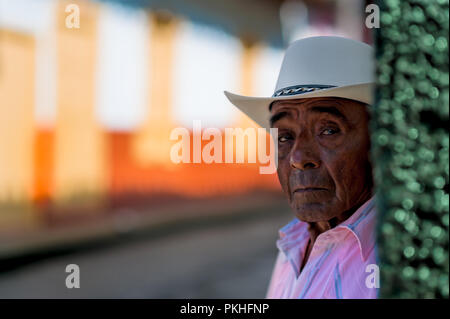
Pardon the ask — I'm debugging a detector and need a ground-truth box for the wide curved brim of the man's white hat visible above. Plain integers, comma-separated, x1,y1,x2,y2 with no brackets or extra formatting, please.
224,83,374,128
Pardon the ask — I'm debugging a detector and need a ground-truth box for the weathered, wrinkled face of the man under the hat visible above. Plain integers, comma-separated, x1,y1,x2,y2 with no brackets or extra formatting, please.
271,98,372,222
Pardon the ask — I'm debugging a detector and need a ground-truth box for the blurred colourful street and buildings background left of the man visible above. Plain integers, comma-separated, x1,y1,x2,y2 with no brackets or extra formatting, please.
0,0,372,298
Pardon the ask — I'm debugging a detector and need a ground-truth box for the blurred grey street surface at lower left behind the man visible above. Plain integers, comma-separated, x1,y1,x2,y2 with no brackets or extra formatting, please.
0,207,293,298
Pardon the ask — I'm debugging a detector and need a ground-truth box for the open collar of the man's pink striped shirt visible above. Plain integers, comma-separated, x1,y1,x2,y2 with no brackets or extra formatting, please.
277,196,376,269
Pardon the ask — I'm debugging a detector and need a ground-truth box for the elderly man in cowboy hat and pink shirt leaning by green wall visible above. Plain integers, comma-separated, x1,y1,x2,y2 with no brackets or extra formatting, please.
225,37,379,298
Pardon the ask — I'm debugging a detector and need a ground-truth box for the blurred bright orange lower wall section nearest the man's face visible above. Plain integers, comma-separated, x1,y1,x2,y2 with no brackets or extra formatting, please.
108,133,279,197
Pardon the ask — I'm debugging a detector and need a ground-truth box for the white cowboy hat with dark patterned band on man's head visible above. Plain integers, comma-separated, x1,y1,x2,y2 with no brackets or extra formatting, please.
224,36,374,128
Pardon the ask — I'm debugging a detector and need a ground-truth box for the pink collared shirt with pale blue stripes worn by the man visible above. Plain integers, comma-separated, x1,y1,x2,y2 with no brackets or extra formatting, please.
266,197,379,299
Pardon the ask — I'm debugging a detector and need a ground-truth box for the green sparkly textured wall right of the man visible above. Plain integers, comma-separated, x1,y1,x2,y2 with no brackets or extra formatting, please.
372,0,449,298
